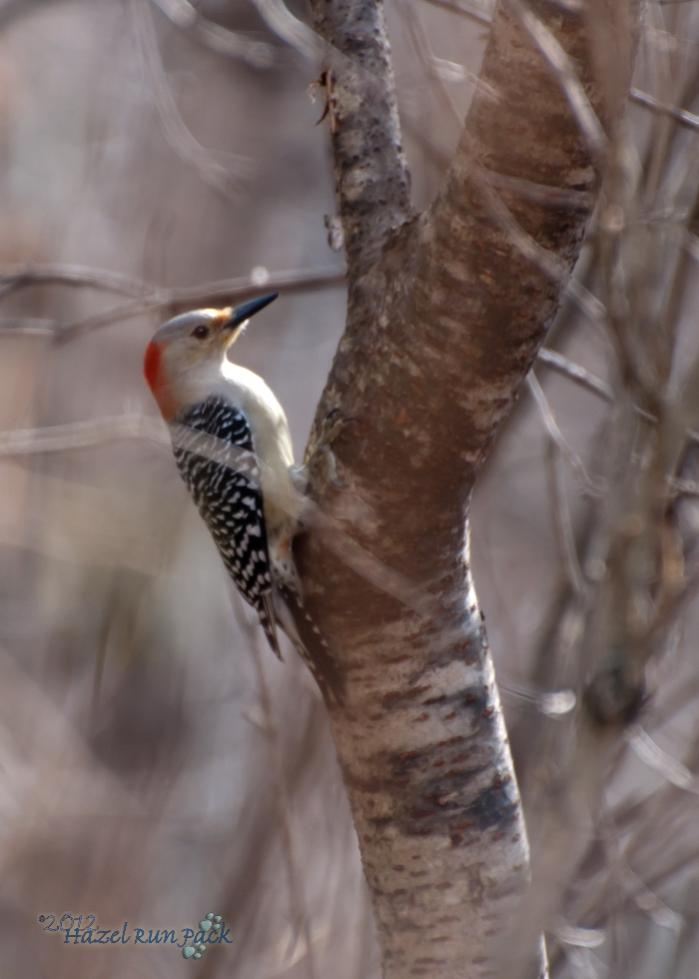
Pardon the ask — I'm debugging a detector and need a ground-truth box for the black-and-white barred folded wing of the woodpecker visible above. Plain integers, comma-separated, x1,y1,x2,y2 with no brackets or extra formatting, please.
172,397,281,658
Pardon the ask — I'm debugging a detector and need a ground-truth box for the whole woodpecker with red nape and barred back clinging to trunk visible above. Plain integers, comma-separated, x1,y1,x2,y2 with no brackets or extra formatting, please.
144,293,341,699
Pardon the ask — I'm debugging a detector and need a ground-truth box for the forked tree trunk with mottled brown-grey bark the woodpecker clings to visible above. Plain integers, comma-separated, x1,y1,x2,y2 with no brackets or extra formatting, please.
298,0,628,979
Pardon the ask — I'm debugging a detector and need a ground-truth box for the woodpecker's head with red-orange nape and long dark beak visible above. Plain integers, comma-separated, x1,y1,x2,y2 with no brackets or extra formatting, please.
143,292,277,419
